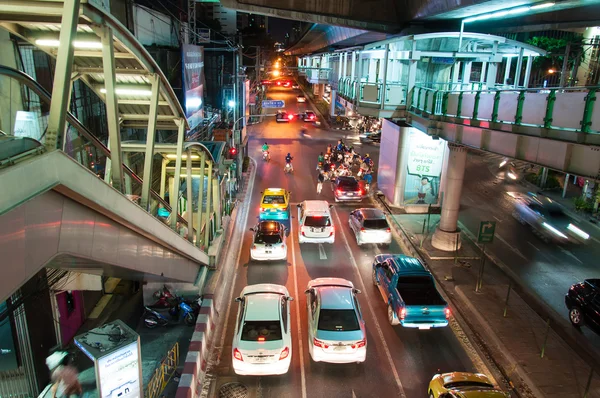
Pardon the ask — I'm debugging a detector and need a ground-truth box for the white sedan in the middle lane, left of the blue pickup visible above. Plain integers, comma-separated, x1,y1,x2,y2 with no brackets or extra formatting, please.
305,278,367,363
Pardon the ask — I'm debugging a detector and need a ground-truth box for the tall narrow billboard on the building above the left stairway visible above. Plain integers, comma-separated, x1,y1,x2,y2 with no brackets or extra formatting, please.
181,44,205,129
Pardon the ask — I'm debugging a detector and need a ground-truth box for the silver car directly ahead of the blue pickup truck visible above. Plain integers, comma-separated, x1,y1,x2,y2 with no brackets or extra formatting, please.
348,208,392,246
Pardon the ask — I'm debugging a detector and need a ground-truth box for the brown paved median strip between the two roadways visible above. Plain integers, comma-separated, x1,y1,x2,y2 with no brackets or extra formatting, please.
384,214,600,398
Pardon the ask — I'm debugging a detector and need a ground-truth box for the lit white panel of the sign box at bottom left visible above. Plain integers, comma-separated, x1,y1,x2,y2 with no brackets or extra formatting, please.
98,341,142,398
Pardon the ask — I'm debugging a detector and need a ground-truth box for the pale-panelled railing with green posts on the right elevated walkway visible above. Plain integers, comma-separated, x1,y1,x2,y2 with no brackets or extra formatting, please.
410,86,600,133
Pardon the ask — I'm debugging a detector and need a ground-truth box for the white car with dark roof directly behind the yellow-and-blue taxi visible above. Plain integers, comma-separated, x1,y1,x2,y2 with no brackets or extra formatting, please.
250,221,287,261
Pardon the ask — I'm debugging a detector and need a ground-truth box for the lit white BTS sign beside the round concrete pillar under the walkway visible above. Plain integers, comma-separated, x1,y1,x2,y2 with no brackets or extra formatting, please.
404,129,446,204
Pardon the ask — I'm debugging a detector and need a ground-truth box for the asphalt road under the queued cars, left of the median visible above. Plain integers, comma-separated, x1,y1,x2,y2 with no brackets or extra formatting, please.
214,85,475,398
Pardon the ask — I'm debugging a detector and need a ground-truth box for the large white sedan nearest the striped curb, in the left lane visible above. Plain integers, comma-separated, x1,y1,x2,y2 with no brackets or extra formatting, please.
231,283,293,376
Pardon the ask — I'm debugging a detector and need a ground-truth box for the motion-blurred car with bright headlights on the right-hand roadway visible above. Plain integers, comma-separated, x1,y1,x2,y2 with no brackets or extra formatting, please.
508,192,590,244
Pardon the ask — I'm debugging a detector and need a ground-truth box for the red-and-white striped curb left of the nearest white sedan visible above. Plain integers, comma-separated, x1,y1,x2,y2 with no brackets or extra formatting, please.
175,294,215,398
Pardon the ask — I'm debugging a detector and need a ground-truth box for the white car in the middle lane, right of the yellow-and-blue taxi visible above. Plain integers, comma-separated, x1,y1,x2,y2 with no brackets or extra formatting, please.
298,200,335,244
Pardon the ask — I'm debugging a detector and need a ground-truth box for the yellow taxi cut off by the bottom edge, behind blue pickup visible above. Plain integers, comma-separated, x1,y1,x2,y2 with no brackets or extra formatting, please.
428,372,510,398
